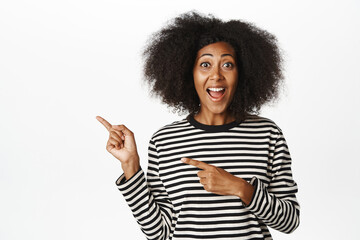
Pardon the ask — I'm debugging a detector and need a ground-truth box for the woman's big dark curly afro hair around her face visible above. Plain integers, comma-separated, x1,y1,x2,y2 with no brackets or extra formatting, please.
143,11,284,122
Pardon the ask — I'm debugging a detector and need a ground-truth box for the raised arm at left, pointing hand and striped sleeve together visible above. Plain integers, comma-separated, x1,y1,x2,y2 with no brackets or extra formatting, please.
96,116,174,240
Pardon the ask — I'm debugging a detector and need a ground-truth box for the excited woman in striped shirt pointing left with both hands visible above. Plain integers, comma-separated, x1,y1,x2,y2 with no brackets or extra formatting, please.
97,12,300,240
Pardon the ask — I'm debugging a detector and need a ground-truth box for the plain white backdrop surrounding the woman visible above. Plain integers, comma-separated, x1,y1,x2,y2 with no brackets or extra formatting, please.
0,0,360,240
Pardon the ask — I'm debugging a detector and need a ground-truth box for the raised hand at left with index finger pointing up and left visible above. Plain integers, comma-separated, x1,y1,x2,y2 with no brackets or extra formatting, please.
96,116,140,179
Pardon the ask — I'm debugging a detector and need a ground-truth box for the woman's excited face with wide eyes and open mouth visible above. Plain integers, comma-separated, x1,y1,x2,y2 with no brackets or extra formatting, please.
193,42,238,117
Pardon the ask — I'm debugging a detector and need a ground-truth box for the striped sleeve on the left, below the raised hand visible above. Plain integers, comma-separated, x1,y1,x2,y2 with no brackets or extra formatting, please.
116,140,174,240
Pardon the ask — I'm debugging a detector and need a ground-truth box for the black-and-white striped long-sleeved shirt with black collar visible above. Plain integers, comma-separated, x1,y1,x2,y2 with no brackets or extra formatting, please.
116,115,300,240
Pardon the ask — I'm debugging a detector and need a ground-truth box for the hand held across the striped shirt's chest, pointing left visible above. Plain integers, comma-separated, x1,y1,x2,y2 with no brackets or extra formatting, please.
181,158,254,205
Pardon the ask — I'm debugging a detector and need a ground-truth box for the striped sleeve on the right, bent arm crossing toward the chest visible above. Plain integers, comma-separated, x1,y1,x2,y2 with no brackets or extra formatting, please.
246,130,300,233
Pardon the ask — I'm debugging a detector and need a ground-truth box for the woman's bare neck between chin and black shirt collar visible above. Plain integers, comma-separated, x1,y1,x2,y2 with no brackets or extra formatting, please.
194,110,235,125
